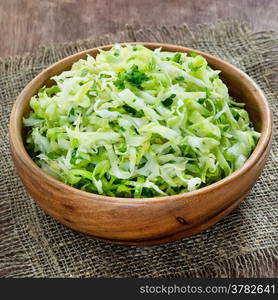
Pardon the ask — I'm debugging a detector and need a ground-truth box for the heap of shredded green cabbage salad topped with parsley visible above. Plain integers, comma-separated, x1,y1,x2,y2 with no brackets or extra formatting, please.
23,45,260,198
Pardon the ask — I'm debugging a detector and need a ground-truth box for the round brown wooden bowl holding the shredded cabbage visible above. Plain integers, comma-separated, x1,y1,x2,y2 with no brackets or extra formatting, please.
9,43,272,245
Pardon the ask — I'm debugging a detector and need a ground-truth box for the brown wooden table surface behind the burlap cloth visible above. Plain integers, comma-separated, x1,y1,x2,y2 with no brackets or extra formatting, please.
0,0,278,57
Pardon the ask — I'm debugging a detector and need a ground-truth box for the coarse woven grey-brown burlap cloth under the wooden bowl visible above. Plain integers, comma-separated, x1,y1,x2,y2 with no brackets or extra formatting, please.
0,22,278,277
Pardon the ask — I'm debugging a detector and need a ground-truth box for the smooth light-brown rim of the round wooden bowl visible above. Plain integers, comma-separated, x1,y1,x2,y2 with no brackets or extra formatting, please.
9,42,273,204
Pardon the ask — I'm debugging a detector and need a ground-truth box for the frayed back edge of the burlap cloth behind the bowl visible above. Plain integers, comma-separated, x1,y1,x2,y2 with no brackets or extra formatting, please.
0,20,278,93
